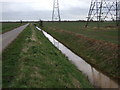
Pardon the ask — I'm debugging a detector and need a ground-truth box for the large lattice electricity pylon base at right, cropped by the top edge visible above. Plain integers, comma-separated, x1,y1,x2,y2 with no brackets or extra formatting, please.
86,0,118,27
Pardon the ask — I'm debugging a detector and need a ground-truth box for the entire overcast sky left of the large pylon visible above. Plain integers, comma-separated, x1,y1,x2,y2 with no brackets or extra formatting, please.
0,0,91,20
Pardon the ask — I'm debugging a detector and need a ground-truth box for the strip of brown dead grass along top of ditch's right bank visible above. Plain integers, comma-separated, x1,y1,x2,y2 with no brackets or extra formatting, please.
56,30,118,60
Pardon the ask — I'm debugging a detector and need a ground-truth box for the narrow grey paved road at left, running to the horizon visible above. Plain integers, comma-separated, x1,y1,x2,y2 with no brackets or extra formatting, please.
0,24,29,51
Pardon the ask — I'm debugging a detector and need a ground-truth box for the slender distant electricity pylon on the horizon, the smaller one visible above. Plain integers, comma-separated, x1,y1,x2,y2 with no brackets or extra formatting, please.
52,0,61,21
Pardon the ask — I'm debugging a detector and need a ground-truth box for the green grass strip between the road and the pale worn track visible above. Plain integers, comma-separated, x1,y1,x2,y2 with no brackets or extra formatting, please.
2,23,31,87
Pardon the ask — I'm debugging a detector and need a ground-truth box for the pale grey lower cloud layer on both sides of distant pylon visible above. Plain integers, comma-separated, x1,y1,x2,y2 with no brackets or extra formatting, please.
2,0,88,20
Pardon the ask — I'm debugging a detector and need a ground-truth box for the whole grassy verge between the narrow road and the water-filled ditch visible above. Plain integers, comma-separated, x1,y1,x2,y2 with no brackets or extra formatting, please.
2,25,92,88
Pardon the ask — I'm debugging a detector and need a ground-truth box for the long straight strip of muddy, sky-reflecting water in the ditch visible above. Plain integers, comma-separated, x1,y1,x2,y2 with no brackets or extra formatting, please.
36,27,120,88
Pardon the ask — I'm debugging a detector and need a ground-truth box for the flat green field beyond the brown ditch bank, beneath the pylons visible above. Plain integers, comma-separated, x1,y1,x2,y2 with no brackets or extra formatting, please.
44,22,118,44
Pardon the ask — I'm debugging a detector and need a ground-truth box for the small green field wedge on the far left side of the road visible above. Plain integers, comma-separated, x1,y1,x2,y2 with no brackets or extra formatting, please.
0,23,24,33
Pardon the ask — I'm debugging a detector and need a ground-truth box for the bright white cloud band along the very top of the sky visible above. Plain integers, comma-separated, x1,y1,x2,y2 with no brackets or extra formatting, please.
1,0,90,10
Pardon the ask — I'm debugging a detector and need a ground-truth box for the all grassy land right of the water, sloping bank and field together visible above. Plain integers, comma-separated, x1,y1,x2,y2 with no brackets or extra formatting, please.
39,22,120,80
